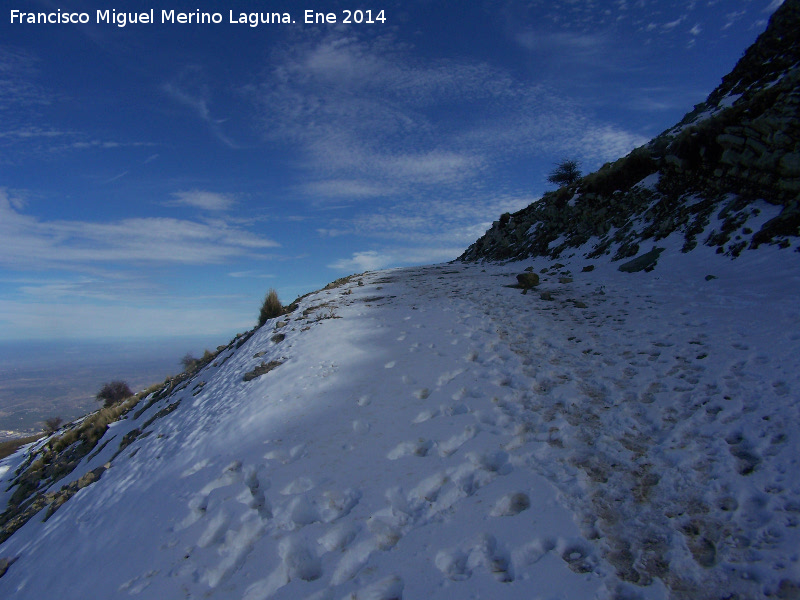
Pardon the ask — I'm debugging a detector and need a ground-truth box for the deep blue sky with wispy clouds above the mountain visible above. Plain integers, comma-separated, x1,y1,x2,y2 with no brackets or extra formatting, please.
0,0,780,343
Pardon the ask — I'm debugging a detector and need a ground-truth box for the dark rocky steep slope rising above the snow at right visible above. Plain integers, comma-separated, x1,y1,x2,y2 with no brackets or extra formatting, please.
460,0,800,266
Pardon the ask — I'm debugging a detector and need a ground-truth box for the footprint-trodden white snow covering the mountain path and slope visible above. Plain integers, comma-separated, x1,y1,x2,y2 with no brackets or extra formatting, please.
0,245,800,600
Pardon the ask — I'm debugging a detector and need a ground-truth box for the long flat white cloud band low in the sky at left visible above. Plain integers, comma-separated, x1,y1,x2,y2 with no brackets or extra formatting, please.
0,190,279,269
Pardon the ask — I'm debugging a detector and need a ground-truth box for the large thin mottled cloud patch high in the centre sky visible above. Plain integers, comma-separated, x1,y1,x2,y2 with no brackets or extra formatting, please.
253,34,648,201
